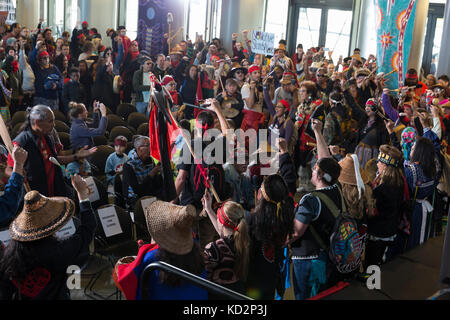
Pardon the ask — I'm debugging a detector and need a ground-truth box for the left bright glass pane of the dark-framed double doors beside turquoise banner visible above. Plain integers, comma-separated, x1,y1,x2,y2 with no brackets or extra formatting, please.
296,8,322,51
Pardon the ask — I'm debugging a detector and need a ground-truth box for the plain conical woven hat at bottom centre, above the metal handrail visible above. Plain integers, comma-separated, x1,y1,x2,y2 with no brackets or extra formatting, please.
144,200,196,255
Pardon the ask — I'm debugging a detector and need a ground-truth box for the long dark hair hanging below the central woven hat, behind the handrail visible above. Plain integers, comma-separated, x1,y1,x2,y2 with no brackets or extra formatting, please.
158,242,205,287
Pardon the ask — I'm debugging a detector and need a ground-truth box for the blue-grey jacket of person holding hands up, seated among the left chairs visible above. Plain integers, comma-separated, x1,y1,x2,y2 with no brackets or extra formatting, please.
70,112,108,150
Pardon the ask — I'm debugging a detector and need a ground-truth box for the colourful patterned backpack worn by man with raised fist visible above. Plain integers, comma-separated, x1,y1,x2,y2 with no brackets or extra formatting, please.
309,188,364,273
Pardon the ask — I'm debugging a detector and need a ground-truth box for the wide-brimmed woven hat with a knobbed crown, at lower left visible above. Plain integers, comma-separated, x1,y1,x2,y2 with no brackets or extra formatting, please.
9,191,75,242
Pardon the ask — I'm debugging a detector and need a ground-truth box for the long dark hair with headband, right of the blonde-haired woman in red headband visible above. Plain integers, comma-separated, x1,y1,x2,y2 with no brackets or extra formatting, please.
253,174,294,247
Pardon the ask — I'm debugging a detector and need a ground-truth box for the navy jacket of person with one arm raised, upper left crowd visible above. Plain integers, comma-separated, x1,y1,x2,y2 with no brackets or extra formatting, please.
29,48,64,100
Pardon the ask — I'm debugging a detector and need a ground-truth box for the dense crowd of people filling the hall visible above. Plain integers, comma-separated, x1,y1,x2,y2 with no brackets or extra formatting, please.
0,21,450,300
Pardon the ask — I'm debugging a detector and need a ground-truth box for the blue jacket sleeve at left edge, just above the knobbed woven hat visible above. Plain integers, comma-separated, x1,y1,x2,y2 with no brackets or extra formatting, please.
0,172,23,228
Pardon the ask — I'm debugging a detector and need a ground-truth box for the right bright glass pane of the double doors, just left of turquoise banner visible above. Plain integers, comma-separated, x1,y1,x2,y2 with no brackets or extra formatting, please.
325,9,352,61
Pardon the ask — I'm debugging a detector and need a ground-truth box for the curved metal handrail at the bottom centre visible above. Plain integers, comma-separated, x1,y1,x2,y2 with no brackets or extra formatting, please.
141,261,253,300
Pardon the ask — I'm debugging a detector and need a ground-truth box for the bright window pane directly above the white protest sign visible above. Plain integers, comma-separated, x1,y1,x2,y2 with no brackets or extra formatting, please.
264,0,289,45
